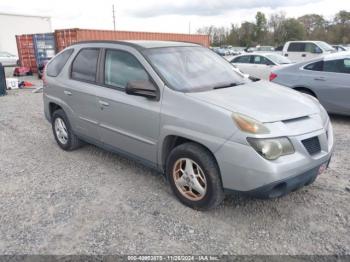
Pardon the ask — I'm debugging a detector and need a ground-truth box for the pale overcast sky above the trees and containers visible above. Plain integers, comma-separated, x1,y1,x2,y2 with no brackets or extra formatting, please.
0,0,350,33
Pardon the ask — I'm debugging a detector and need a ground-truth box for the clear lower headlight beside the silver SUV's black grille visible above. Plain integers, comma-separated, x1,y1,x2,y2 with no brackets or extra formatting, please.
247,137,295,160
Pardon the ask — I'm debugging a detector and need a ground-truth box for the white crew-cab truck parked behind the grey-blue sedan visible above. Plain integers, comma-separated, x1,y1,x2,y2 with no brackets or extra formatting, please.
282,41,336,62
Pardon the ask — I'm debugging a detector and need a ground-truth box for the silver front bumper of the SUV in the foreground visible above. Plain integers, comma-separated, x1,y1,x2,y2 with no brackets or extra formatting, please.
215,123,333,193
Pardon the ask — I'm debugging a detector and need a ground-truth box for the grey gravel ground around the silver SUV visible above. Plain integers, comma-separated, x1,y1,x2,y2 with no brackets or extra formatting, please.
0,87,350,255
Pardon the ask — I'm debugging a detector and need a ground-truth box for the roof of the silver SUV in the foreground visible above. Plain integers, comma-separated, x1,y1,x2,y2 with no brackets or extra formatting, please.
74,40,200,49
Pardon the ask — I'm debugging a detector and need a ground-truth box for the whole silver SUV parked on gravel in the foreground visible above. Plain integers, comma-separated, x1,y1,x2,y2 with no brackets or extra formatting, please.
44,41,333,209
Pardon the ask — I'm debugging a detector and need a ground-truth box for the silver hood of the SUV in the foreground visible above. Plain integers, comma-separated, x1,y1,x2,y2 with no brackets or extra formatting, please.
186,81,319,123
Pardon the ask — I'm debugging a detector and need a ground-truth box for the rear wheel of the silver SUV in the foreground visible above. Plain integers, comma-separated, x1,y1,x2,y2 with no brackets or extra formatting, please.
51,109,82,151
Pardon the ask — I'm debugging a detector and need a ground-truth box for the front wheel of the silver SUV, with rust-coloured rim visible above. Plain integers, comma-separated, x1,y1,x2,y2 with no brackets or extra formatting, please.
166,143,224,210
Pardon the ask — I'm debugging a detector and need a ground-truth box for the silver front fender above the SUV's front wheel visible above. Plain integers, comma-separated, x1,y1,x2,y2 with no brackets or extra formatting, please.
158,87,238,166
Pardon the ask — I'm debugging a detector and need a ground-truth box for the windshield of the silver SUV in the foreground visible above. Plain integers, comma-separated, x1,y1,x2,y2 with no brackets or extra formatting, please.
144,47,245,92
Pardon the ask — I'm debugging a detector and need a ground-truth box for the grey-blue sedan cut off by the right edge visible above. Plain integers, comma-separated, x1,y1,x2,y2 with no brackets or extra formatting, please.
271,52,350,115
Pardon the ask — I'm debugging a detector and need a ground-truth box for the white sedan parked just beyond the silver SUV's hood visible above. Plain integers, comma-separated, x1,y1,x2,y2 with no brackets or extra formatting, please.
231,53,292,80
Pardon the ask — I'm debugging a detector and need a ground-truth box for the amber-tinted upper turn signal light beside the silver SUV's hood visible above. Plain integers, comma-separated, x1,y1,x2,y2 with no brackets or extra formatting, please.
232,113,270,134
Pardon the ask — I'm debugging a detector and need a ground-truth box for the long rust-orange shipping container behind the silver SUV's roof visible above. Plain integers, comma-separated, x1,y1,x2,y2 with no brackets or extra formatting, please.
55,28,210,51
